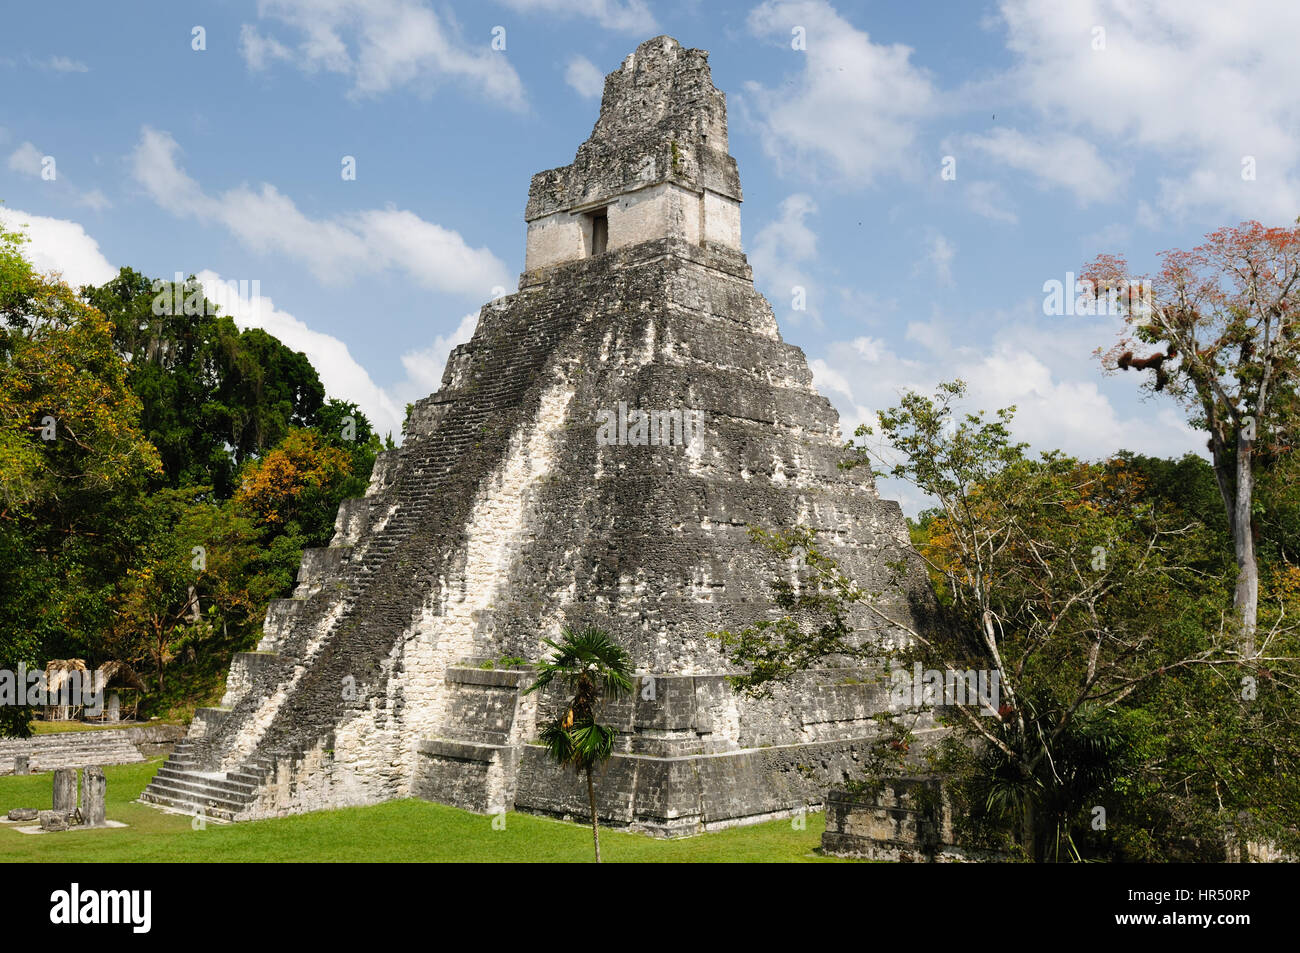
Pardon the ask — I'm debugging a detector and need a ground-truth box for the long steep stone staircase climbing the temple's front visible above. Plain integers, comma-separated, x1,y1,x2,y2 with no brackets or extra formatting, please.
140,278,571,819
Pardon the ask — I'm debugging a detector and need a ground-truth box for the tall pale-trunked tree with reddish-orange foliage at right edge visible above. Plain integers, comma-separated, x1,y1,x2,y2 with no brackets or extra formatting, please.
1084,221,1300,657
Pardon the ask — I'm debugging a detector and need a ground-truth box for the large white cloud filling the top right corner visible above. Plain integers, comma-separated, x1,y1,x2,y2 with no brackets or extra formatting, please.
1001,0,1300,224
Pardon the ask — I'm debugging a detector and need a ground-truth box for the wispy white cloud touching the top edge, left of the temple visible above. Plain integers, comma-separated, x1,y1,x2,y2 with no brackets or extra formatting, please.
239,0,525,109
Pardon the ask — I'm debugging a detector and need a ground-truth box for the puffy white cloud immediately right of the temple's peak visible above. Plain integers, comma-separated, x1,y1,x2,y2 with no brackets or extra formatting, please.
742,0,935,186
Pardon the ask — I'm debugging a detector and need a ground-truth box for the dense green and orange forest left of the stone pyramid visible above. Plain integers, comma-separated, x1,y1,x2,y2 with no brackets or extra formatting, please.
0,223,393,735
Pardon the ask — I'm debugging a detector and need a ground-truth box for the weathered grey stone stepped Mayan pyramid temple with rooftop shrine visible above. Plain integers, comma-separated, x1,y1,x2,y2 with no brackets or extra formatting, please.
142,36,928,835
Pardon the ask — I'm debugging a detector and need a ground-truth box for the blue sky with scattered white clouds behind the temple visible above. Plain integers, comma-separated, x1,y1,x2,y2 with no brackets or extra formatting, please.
0,0,1300,511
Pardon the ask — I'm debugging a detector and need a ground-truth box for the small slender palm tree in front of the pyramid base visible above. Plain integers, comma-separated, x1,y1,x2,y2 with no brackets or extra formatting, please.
524,625,632,863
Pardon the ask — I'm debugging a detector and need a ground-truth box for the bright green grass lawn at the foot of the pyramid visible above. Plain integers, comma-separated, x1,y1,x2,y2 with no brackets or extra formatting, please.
0,761,833,863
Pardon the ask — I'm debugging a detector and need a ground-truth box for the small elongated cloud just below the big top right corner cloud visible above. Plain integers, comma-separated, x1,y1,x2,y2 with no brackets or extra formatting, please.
963,129,1128,207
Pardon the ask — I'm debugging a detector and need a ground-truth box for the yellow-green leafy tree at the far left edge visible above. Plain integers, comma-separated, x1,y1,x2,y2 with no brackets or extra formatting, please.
0,224,160,733
